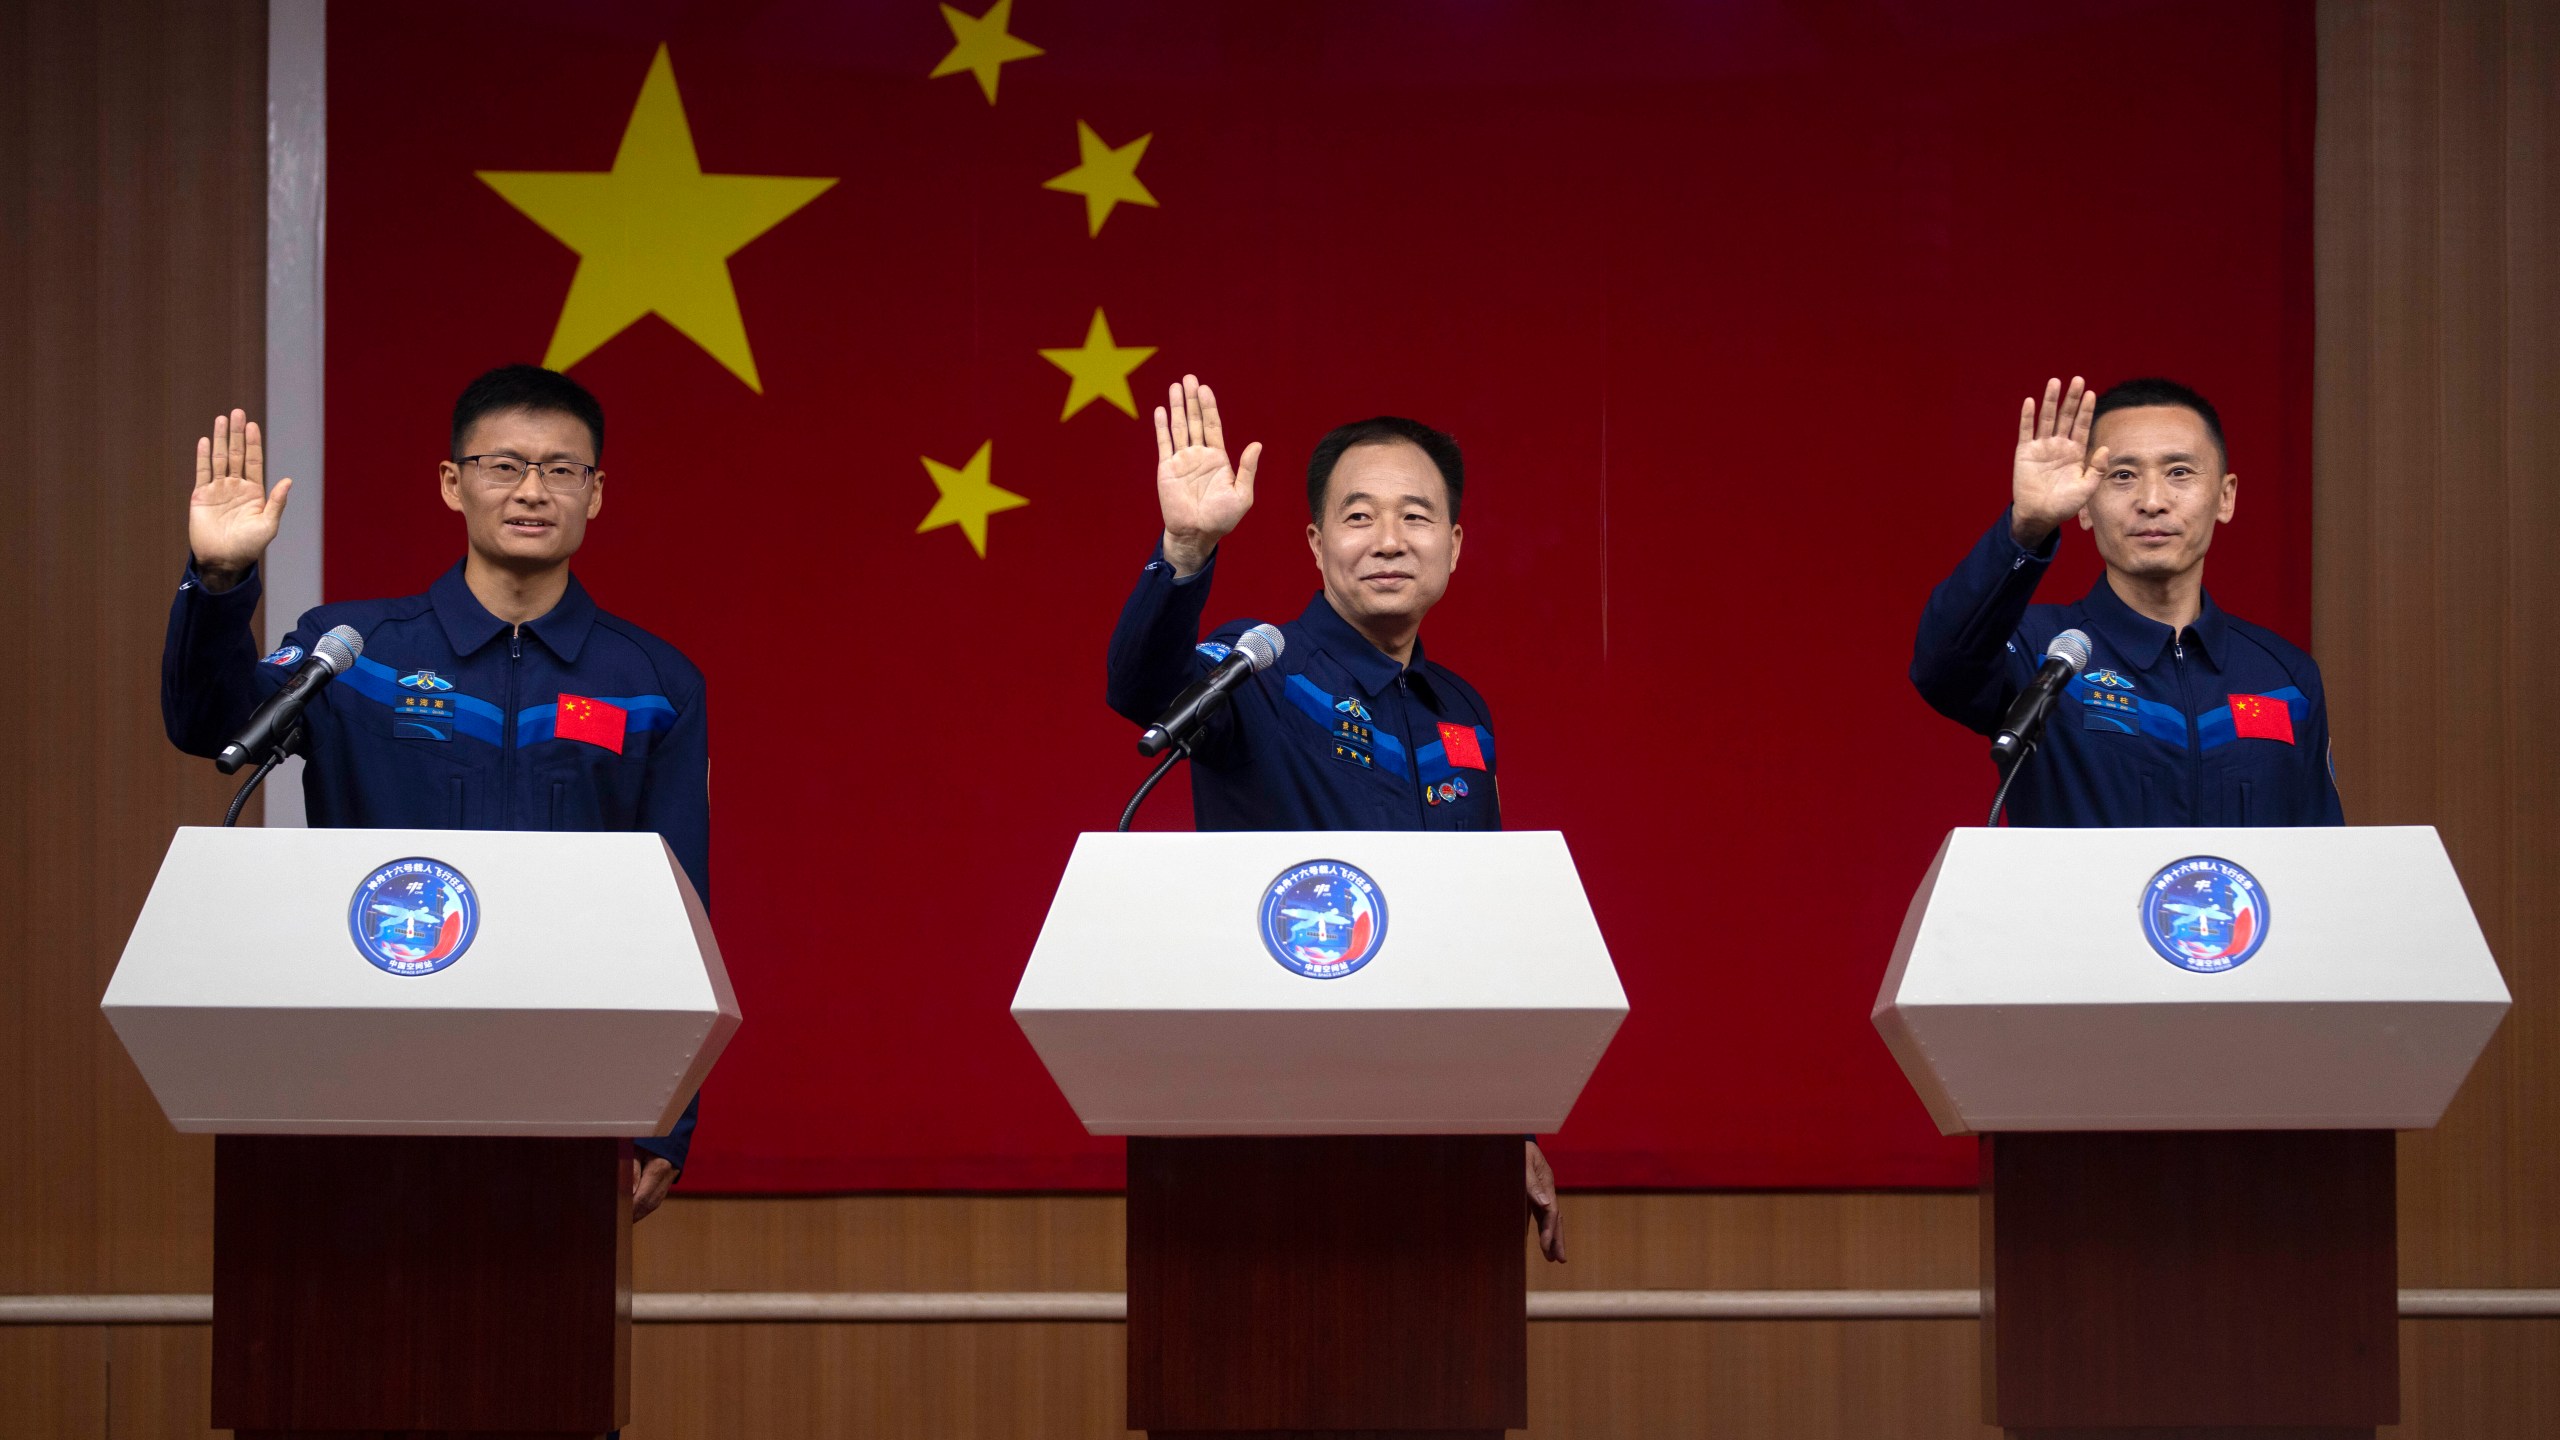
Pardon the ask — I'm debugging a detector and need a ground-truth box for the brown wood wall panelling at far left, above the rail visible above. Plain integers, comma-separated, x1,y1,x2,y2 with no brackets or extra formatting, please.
0,0,266,1291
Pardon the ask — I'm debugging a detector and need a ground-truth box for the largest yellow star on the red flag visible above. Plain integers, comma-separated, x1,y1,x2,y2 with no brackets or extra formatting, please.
479,46,835,392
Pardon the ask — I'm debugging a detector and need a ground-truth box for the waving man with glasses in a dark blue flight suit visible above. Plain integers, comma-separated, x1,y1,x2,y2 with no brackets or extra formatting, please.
161,364,712,1220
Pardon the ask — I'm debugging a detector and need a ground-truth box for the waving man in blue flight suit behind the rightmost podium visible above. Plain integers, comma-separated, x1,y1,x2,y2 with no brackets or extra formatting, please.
1912,377,2345,825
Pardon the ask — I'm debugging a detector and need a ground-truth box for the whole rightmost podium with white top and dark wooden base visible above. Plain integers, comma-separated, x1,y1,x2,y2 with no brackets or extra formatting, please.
1874,828,2509,1440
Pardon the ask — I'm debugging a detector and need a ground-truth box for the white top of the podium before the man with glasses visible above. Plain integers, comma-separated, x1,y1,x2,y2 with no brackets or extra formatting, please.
102,828,740,1135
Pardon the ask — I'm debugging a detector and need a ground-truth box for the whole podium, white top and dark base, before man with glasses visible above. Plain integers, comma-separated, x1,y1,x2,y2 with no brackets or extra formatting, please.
102,828,740,1437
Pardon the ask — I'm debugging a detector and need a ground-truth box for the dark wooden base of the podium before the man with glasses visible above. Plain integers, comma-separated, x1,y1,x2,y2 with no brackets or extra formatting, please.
212,1135,632,1440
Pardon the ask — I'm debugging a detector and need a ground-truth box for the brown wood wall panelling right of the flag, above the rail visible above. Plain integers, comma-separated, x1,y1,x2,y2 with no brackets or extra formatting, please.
2314,0,2560,1281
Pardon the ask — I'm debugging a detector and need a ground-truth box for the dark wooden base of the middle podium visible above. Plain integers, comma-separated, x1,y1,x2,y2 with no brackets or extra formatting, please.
1129,1135,1528,1440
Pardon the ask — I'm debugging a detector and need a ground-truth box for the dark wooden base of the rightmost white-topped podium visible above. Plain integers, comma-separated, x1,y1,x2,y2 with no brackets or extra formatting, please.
1981,1130,2399,1440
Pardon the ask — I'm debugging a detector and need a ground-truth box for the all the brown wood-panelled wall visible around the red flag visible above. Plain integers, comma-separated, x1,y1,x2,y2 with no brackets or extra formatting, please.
0,0,2560,1440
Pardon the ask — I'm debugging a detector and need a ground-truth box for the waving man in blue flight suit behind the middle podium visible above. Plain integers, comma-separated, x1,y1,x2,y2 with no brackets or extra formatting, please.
1108,374,1564,1261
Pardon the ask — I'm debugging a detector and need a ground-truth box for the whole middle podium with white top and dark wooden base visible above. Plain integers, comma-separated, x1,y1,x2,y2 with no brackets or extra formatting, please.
1014,830,1626,1440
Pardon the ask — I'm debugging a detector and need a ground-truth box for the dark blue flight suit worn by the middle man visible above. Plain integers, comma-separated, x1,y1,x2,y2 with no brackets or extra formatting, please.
1108,543,1503,830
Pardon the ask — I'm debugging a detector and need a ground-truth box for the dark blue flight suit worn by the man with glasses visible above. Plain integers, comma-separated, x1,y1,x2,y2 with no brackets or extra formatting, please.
161,564,712,1171
